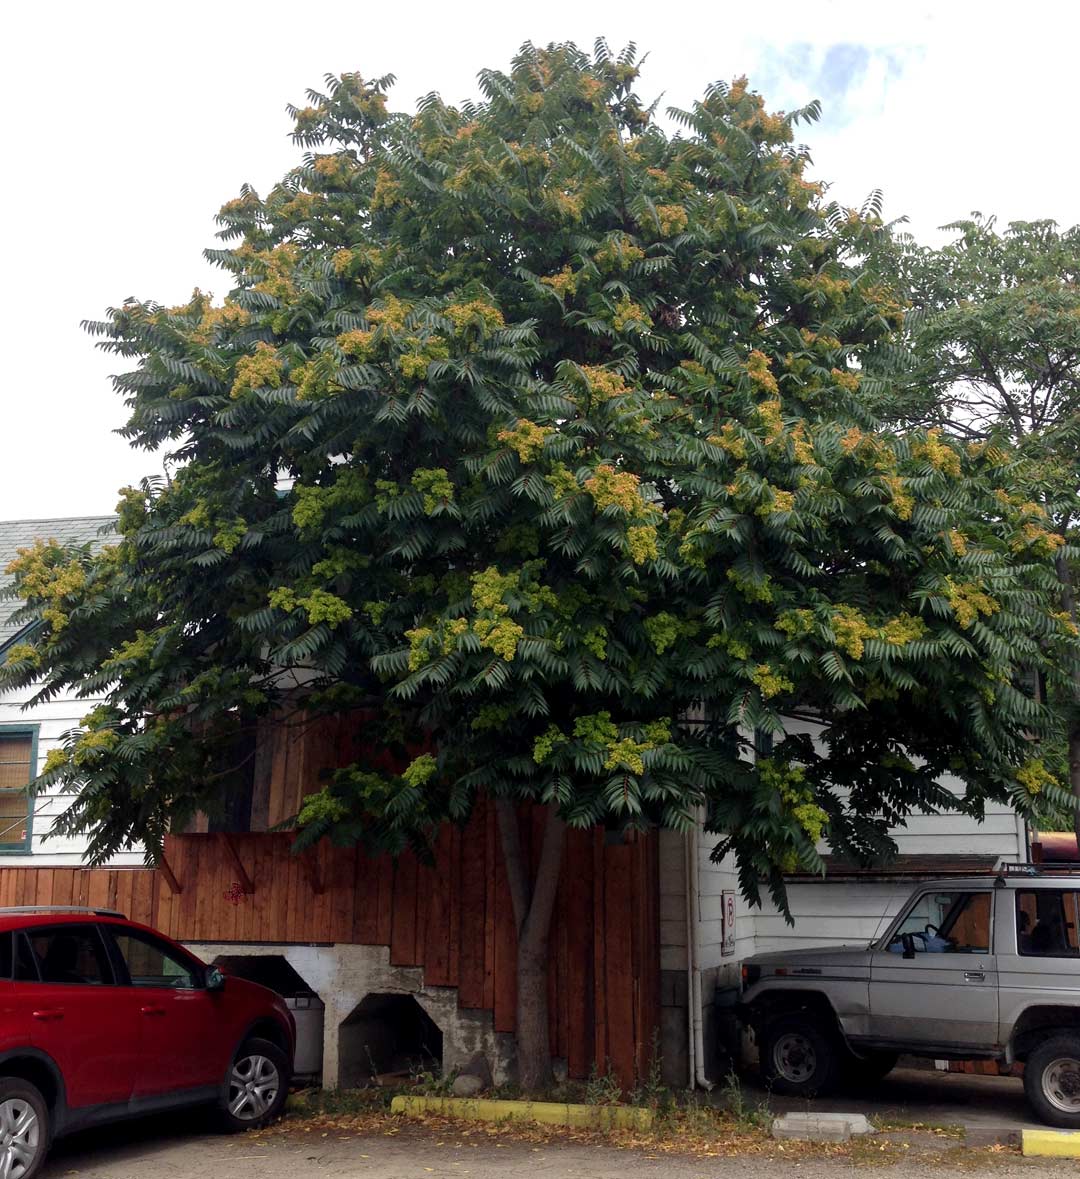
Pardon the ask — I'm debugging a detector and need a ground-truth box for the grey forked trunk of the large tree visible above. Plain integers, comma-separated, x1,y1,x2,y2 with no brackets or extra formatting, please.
495,798,566,1093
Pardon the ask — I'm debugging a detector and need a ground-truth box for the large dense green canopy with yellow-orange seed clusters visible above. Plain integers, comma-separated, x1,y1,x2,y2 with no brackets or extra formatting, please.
2,42,1074,903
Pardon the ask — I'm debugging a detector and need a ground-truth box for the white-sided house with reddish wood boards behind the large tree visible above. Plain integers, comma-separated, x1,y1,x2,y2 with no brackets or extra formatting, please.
0,519,1030,1087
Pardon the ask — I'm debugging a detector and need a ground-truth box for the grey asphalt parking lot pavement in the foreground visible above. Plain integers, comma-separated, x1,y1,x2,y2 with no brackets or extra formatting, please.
41,1069,1056,1179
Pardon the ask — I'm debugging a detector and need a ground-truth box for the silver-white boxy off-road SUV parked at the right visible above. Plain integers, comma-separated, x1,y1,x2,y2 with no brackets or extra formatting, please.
738,865,1080,1129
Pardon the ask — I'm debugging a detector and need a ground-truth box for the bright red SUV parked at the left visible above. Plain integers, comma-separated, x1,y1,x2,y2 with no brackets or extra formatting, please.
0,908,296,1179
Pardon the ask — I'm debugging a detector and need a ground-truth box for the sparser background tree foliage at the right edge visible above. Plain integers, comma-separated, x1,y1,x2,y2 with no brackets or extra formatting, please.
875,213,1080,830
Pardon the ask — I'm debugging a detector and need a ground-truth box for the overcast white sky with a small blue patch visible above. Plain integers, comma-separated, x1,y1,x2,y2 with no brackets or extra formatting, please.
0,0,1080,520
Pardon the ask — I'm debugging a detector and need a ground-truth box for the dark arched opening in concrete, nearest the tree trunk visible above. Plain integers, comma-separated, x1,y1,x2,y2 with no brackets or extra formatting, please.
338,994,442,1088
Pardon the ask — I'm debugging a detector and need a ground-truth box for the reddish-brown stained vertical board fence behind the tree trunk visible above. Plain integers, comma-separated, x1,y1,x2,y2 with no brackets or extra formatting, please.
0,792,659,1085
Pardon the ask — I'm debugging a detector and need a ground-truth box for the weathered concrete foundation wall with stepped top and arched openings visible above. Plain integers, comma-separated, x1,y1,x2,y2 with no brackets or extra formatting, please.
187,942,515,1088
